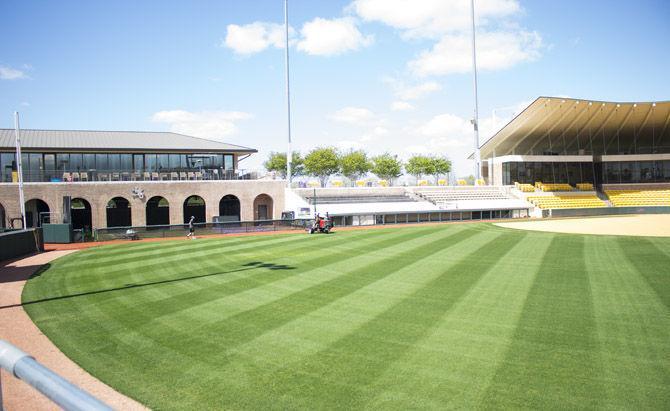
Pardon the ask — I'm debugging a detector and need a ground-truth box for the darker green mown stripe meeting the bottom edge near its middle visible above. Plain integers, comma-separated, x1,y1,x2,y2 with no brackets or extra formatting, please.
227,234,516,409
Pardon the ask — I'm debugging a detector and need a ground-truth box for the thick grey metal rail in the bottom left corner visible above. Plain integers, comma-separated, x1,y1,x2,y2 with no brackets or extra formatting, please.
0,340,112,411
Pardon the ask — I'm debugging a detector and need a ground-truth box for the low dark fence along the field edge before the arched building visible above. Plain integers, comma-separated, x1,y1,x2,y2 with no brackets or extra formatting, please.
93,219,312,241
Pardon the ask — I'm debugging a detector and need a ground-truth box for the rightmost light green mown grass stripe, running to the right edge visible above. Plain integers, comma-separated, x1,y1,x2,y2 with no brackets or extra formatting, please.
585,237,670,410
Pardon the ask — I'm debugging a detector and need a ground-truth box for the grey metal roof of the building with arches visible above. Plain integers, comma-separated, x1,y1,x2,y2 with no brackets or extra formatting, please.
0,129,257,153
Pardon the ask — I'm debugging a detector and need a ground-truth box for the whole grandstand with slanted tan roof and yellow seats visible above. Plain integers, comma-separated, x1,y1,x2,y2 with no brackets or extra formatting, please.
481,97,670,209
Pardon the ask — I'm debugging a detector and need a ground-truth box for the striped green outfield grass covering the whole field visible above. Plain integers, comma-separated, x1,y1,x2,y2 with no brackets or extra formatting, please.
23,224,670,409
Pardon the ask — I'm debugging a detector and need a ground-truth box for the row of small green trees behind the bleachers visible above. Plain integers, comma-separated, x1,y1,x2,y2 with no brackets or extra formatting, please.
263,147,451,187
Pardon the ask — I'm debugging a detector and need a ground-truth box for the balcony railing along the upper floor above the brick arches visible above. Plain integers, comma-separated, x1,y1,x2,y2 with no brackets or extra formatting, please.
0,168,264,183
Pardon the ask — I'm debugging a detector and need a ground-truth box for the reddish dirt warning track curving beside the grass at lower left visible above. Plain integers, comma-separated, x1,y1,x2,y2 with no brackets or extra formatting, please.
0,250,146,411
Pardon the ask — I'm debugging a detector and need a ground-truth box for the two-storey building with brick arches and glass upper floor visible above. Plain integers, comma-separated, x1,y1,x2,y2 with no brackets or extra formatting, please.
0,130,284,229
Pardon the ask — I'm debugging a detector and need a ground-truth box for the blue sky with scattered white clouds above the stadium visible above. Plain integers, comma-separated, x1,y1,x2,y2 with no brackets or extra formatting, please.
0,0,670,175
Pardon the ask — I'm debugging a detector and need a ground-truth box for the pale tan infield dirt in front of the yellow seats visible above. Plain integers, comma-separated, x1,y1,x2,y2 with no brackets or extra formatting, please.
496,214,670,237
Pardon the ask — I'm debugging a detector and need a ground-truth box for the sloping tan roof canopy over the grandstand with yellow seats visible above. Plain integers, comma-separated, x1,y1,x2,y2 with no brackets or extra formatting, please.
481,97,670,158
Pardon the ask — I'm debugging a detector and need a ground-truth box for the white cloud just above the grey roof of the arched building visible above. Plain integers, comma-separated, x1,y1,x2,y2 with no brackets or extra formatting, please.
151,110,252,140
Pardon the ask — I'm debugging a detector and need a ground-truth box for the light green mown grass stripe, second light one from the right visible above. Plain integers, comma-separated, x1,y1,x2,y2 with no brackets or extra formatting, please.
365,230,551,409
